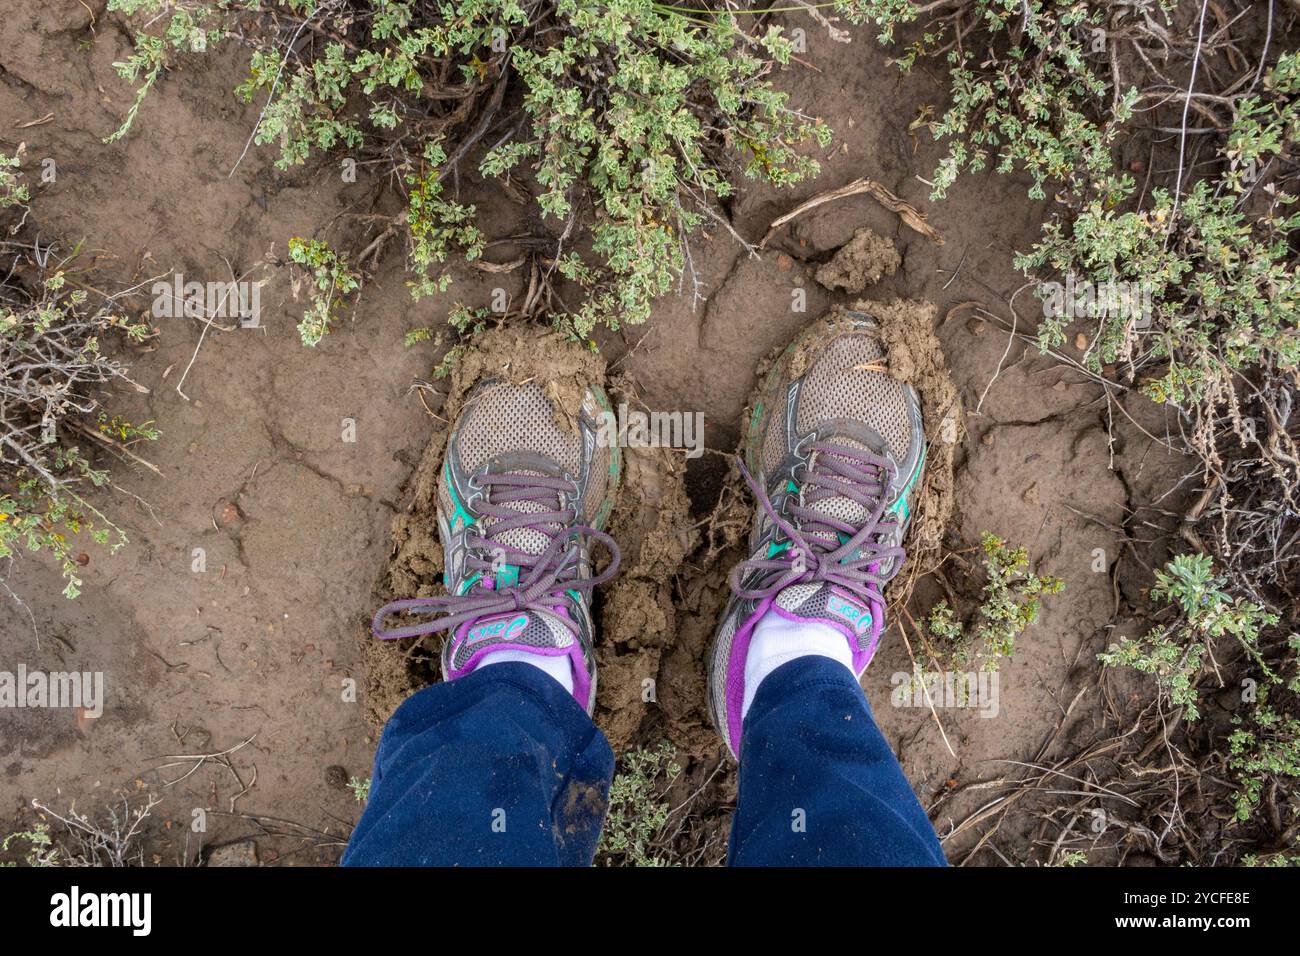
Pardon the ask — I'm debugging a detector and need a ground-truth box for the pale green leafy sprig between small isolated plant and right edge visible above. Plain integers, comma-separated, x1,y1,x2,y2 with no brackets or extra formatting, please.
1097,554,1278,721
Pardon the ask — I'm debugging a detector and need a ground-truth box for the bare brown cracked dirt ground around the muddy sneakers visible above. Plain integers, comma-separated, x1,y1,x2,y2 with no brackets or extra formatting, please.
0,0,1182,864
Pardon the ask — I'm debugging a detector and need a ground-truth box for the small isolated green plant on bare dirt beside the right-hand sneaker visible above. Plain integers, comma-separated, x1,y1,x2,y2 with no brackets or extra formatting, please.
926,532,1065,671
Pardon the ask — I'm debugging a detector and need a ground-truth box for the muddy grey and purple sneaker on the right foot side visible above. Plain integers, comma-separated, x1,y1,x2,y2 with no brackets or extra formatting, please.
709,312,926,757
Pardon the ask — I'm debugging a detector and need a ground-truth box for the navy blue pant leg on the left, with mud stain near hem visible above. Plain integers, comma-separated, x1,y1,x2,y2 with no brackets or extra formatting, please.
342,663,614,866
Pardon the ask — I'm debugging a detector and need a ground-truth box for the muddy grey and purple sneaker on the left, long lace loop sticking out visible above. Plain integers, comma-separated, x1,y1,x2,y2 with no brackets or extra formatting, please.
372,381,620,714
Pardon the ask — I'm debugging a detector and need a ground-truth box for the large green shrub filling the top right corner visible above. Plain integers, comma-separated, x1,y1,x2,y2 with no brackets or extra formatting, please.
863,0,1300,497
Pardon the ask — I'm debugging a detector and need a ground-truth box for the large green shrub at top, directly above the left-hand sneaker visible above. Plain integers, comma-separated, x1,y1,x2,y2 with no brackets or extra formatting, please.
111,0,857,341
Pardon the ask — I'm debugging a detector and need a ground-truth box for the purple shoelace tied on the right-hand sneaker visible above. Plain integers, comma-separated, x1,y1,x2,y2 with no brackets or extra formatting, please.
731,442,904,604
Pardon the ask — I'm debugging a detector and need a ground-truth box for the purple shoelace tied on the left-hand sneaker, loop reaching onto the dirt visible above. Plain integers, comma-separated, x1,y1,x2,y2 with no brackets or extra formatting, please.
371,473,619,640
